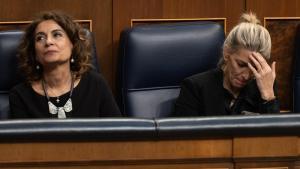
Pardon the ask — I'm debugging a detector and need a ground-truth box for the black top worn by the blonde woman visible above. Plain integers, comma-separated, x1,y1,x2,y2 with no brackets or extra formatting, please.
175,69,279,116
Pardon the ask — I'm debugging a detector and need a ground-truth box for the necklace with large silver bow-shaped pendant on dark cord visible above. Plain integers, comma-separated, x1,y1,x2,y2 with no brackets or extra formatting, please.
42,76,74,119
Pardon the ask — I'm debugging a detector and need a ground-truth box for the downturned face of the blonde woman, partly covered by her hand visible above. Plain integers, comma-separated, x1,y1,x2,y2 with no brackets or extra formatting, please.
224,49,253,90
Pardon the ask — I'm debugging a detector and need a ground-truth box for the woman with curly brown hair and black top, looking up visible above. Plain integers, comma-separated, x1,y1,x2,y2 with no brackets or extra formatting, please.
9,11,121,118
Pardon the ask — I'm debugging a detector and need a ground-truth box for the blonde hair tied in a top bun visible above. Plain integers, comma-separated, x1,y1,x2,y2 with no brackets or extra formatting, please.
219,12,271,67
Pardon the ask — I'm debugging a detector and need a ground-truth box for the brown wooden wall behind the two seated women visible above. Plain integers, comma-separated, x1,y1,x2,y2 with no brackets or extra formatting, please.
0,0,300,109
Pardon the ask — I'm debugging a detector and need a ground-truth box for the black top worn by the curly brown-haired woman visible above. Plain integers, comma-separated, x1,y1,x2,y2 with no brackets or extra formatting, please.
9,71,121,118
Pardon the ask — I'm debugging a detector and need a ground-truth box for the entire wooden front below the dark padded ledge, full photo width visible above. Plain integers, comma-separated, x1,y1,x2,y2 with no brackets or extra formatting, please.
0,136,300,169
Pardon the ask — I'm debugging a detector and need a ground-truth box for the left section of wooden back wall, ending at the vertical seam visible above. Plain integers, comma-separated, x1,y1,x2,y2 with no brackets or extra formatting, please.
0,0,113,87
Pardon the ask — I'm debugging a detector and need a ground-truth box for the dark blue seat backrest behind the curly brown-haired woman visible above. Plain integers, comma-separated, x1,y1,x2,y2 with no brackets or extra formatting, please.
0,30,100,119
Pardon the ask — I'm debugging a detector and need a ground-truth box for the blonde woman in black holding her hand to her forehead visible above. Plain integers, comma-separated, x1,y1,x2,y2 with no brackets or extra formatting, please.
175,13,279,116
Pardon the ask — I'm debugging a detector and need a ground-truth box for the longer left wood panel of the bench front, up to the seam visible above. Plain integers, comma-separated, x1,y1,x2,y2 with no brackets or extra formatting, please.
0,139,232,169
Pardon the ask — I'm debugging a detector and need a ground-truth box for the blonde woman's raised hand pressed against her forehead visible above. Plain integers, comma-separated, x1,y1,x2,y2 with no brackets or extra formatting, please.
248,52,276,101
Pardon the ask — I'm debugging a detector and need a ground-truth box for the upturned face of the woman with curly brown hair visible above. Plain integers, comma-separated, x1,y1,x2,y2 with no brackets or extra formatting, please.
34,20,73,67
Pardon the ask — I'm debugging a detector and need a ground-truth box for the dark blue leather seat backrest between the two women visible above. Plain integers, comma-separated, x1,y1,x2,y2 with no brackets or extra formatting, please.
117,21,225,118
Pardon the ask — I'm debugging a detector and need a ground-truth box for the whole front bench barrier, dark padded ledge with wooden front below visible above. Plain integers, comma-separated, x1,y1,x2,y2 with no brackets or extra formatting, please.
0,114,300,169
